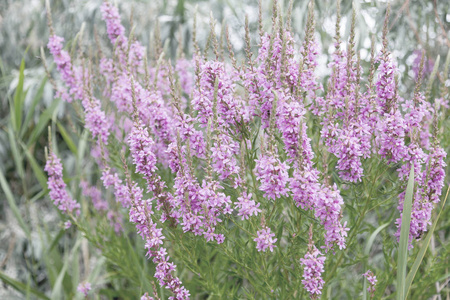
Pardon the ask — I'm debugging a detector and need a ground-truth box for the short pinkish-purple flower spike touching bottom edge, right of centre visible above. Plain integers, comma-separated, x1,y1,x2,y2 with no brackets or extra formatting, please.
300,246,326,299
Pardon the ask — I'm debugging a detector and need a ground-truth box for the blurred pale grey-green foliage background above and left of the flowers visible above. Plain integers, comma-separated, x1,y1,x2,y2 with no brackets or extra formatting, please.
0,0,450,299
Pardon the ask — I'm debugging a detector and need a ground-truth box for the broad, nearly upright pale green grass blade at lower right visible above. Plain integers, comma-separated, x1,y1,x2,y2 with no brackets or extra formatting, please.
396,165,414,300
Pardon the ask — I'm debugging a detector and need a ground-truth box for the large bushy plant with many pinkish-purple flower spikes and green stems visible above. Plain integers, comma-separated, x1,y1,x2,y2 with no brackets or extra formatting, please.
36,1,446,299
